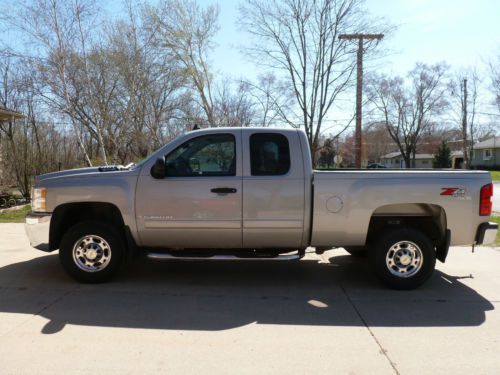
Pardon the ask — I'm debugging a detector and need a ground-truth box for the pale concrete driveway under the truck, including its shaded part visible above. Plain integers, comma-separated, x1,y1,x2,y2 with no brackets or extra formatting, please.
0,224,500,375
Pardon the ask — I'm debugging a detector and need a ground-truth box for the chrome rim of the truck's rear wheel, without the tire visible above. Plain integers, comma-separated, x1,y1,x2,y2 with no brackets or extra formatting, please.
385,241,424,279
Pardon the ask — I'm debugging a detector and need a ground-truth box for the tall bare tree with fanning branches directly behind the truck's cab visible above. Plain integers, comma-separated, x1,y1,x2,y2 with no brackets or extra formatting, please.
240,0,382,163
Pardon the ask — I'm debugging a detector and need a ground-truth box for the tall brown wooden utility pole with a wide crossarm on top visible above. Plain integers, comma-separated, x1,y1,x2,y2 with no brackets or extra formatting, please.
339,34,384,168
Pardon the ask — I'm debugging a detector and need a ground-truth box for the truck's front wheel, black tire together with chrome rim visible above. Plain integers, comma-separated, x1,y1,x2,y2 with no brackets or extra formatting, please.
59,221,126,283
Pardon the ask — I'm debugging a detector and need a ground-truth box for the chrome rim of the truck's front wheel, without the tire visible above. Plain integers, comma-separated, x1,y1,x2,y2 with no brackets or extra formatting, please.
73,234,111,272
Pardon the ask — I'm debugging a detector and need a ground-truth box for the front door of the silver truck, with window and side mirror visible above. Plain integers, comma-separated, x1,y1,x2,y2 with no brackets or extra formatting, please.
136,130,242,248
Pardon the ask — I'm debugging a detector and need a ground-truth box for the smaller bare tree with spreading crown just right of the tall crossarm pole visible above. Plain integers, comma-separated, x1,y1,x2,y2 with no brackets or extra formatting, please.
368,63,448,168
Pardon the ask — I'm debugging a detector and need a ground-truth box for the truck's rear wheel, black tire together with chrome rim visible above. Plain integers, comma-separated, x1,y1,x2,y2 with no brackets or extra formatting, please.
370,228,436,290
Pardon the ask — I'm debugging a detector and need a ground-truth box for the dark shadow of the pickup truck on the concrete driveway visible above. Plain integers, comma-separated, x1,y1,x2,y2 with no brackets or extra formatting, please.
0,255,494,333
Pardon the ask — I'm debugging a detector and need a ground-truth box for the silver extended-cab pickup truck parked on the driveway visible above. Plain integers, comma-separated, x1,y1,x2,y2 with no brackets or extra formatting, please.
26,128,498,289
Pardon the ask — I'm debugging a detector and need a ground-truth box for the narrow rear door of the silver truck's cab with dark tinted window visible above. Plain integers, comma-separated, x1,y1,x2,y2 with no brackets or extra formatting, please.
243,129,305,249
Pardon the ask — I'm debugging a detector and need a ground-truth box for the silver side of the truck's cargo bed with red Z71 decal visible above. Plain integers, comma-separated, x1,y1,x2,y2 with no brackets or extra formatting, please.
311,170,490,246
